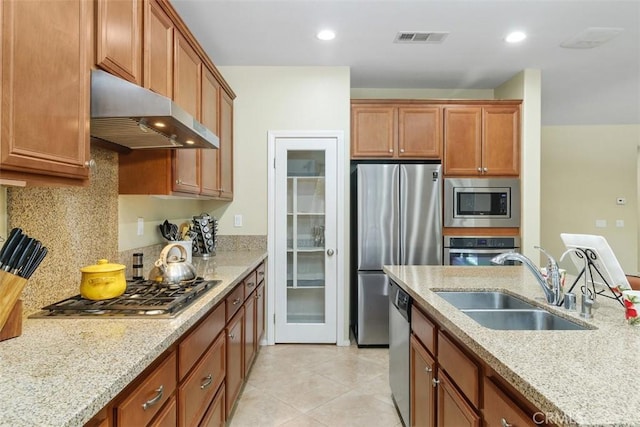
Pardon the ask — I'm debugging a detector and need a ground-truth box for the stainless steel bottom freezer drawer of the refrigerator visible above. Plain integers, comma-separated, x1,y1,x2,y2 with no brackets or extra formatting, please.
355,272,389,346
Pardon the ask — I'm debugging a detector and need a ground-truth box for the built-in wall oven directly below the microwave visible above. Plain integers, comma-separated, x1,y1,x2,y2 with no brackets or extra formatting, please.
443,236,520,266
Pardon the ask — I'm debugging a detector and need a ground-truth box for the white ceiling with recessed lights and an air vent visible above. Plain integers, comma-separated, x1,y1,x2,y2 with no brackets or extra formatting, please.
171,0,640,125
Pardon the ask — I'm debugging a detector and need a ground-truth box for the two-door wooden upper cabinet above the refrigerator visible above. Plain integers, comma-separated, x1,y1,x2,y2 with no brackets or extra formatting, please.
351,103,442,159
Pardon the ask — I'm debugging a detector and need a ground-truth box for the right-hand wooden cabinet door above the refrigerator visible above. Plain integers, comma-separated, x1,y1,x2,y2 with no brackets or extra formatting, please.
397,106,442,159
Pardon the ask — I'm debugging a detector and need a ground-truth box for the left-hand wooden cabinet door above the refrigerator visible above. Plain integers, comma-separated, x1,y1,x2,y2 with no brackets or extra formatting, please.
351,104,398,158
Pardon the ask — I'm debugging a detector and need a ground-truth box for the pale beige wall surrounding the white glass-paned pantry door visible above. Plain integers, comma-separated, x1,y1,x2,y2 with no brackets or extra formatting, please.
219,67,350,344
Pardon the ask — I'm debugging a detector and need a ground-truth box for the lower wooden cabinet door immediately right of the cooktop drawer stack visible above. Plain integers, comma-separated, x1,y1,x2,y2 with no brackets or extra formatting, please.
225,308,244,414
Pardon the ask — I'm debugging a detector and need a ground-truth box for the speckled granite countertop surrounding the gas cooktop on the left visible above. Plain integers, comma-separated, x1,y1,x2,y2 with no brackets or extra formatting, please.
0,251,266,426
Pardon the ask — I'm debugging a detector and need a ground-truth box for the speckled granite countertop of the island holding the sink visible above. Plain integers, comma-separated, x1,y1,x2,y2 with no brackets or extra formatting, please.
384,266,640,426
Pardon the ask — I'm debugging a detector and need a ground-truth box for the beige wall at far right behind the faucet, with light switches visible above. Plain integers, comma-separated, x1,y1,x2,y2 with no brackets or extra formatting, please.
541,125,640,273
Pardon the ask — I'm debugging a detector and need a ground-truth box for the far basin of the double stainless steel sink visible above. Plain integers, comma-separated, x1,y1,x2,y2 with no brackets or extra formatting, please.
436,291,539,310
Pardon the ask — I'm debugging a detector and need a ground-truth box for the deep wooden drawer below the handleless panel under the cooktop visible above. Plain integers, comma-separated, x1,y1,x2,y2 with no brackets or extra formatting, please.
178,333,225,426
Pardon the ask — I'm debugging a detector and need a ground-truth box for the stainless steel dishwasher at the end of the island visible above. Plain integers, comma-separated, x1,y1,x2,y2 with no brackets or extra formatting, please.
389,281,412,426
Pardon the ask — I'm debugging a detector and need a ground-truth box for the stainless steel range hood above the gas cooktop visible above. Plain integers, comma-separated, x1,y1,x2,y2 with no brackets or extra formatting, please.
91,70,220,150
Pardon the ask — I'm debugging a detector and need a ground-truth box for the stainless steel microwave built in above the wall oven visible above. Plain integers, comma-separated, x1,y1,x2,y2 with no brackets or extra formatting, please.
444,178,520,227
